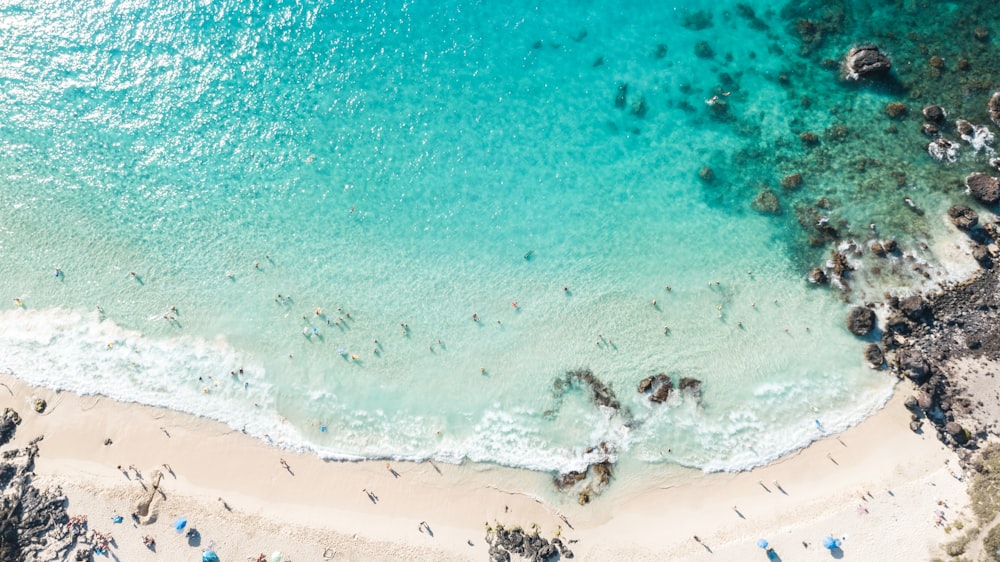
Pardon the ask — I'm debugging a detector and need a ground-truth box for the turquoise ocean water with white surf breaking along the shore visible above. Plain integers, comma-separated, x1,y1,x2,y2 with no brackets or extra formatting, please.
0,0,985,482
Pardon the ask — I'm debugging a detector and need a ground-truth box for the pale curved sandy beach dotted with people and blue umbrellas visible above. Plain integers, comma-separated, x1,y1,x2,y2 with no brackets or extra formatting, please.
2,370,968,562
